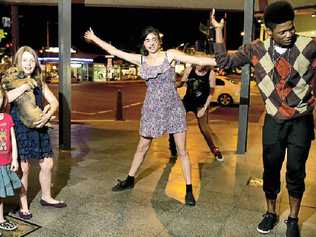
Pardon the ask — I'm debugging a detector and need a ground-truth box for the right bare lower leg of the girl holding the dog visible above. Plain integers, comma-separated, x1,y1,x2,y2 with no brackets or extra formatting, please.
39,158,60,204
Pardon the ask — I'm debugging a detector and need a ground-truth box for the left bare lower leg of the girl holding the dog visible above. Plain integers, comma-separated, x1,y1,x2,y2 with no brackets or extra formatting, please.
20,161,30,214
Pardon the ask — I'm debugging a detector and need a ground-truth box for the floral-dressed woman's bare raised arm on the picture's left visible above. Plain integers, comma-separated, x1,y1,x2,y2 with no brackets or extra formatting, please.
84,28,141,65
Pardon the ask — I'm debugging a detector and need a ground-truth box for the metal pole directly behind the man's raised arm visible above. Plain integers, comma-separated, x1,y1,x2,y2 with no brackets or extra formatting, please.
237,0,255,154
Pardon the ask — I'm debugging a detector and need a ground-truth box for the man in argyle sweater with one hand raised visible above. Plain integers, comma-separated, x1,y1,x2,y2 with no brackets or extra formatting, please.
211,1,316,237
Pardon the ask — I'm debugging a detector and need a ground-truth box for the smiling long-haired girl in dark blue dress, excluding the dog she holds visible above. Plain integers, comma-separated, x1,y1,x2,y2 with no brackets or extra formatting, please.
1,46,66,219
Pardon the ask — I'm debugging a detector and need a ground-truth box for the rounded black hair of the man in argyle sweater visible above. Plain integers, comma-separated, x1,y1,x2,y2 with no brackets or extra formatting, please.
264,1,295,30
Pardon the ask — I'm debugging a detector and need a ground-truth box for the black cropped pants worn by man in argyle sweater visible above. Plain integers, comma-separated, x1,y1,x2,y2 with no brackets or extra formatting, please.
262,115,314,199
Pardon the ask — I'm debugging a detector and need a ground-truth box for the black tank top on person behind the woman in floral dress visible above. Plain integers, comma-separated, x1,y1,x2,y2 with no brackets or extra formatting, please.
184,69,211,106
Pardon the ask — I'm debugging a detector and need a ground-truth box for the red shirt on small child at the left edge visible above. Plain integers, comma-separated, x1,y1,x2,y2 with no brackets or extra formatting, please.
0,113,14,165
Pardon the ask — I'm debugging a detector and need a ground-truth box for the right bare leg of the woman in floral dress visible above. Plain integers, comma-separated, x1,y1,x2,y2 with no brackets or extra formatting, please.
173,132,192,184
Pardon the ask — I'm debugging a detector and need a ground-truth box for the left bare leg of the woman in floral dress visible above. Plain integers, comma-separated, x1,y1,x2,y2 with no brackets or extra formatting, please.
128,137,152,177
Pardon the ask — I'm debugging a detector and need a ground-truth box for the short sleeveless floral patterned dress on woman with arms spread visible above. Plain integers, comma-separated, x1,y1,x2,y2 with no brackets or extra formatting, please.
139,55,186,138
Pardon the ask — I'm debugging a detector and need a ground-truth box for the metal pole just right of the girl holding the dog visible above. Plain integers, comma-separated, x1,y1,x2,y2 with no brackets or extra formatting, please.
58,0,71,150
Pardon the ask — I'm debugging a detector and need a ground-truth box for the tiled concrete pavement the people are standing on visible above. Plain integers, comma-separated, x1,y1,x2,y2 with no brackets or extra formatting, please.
5,118,316,237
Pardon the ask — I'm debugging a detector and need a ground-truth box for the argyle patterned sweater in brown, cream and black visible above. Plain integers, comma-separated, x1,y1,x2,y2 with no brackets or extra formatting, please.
214,36,316,122
